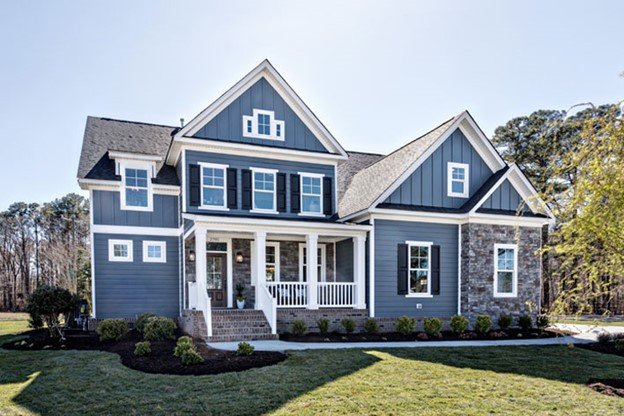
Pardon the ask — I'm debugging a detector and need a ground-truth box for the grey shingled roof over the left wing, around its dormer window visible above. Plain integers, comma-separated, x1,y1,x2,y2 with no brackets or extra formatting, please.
78,116,179,185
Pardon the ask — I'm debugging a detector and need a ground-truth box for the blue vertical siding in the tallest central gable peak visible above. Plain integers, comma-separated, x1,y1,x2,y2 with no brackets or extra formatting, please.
195,78,329,153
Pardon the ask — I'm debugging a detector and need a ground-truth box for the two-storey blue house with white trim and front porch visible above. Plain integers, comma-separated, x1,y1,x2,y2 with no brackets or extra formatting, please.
78,60,552,340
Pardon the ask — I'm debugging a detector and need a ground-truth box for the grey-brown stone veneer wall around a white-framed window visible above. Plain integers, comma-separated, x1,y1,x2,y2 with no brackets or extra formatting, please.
461,224,542,325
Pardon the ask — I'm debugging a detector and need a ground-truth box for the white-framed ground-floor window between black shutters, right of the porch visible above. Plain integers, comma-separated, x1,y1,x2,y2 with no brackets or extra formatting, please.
405,241,433,297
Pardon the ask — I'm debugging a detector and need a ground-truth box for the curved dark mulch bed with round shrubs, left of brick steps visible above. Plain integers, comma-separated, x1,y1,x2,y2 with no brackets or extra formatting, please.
2,330,288,375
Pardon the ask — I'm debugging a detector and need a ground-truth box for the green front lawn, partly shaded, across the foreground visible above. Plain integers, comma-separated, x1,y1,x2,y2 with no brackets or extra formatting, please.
0,316,624,415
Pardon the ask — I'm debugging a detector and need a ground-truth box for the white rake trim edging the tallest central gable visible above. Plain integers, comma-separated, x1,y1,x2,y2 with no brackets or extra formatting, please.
167,59,348,163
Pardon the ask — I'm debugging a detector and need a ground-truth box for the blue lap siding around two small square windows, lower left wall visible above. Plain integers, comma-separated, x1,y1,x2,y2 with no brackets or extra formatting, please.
93,234,180,319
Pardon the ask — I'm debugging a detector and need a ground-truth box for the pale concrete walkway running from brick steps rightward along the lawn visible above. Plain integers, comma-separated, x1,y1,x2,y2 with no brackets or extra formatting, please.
208,324,624,351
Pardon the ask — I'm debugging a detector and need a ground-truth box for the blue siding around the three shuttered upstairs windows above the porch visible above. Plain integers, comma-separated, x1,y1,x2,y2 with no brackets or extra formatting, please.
186,150,336,219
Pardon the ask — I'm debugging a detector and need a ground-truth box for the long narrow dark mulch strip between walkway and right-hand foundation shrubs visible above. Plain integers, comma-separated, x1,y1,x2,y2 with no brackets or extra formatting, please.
279,329,567,342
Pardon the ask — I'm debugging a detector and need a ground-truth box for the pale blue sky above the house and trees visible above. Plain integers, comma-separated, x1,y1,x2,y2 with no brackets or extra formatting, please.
0,0,624,210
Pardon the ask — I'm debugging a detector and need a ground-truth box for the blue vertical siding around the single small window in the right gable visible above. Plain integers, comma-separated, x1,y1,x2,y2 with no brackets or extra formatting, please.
384,129,493,208
